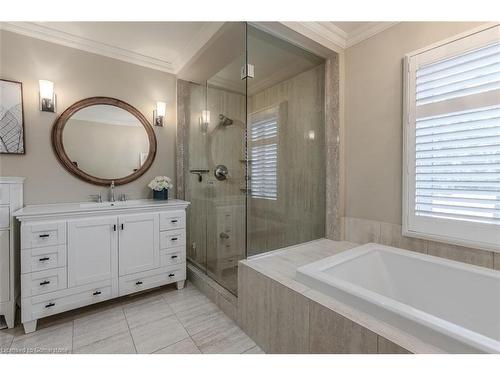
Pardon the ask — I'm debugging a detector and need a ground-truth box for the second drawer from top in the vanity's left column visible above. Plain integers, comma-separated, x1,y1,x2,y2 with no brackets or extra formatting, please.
21,245,66,273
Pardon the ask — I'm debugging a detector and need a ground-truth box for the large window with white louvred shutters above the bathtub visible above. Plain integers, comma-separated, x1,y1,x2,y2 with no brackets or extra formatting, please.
403,26,500,250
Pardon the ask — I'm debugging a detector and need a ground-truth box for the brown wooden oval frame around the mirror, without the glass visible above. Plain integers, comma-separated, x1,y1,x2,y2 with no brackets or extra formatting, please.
52,96,156,186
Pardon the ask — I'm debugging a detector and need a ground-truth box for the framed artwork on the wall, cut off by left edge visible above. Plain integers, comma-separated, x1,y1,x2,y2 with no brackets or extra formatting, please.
0,79,25,154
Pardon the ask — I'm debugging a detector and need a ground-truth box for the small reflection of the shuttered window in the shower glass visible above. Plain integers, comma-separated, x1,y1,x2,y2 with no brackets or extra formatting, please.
248,108,278,200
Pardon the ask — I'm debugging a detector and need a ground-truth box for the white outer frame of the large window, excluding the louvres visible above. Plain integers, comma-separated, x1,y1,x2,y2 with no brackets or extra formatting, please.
402,23,500,253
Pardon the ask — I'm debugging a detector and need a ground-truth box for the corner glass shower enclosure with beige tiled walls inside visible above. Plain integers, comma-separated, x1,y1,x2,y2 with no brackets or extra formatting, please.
182,23,326,294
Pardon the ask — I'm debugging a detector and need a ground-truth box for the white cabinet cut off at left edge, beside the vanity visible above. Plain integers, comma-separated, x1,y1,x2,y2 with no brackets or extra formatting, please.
0,177,24,328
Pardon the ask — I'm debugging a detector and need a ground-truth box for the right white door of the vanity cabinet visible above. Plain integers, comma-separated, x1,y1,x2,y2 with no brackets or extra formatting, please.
118,214,160,276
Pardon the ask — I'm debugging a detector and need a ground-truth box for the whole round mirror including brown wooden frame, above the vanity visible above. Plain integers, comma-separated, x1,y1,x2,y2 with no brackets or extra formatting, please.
52,97,156,185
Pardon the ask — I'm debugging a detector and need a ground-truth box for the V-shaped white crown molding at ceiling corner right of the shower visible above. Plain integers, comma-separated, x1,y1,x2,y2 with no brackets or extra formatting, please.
282,22,398,52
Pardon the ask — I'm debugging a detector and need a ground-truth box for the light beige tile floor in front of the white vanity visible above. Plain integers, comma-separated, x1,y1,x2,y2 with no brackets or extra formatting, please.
0,283,263,354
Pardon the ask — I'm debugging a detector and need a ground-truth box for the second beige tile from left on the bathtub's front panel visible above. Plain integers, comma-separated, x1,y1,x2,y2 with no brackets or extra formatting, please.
268,281,309,354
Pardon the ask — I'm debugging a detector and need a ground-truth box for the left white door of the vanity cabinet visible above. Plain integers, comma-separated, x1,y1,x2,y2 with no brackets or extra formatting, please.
68,217,118,288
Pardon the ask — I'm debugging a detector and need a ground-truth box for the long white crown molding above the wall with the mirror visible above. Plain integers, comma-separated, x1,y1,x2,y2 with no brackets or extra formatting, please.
0,22,176,73
